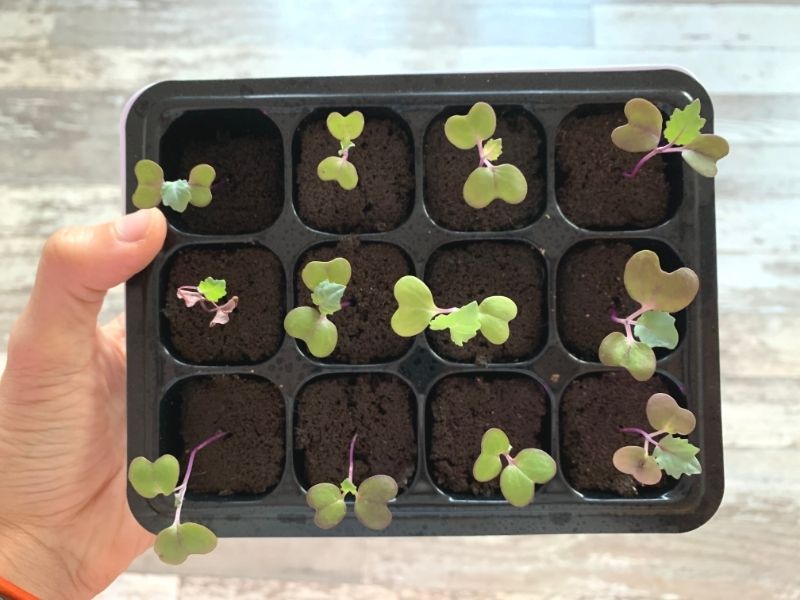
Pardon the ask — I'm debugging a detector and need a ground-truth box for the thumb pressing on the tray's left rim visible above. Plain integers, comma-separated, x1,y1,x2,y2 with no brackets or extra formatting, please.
7,209,167,371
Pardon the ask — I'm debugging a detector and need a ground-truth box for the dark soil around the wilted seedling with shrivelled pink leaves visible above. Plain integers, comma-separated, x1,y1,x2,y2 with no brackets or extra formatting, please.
163,246,286,364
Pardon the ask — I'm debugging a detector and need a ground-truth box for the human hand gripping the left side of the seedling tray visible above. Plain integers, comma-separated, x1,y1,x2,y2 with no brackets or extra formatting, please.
0,209,166,600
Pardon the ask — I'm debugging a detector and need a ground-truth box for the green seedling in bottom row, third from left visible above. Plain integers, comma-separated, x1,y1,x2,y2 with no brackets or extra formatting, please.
472,427,556,508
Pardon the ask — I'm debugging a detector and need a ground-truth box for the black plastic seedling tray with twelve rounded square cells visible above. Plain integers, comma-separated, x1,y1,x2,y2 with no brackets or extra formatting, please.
123,69,723,536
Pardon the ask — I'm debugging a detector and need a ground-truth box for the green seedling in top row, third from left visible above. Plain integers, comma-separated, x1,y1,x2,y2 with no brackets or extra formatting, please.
444,102,528,208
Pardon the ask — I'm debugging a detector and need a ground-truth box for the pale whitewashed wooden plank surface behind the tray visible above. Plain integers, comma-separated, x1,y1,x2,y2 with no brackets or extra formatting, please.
0,0,800,600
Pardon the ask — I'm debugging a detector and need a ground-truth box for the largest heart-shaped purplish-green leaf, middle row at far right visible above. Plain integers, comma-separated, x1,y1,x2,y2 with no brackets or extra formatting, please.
624,250,700,313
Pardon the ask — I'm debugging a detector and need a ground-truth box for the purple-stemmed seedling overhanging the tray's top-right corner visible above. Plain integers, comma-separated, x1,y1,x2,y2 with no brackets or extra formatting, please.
611,98,730,177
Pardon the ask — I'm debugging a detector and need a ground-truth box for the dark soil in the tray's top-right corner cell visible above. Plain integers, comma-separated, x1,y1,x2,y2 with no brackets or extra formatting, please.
556,108,680,230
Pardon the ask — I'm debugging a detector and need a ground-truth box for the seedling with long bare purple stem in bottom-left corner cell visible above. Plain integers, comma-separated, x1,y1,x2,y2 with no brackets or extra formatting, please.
128,431,228,565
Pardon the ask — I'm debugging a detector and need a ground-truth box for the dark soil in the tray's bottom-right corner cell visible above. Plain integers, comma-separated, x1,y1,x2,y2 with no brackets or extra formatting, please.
561,371,681,497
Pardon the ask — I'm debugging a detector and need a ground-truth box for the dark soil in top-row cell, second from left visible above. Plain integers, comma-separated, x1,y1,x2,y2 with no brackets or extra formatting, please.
296,112,414,233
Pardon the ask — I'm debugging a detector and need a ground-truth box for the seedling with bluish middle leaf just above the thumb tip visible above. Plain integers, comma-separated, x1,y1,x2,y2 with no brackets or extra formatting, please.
133,159,217,212
